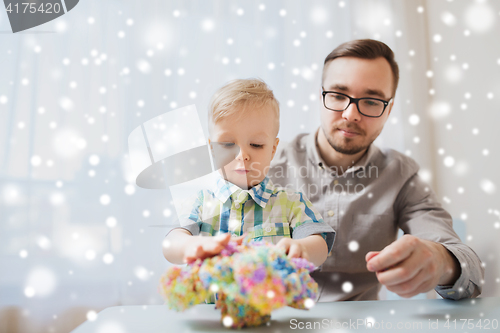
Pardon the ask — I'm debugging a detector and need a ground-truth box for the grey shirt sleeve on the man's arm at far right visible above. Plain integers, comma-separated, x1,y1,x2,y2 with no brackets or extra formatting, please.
395,174,484,300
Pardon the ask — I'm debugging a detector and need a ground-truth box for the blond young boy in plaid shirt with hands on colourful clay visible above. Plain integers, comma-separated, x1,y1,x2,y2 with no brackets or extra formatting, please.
163,79,335,266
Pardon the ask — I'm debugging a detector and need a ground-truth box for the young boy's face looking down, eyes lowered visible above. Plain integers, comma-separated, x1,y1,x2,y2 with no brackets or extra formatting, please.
208,105,279,189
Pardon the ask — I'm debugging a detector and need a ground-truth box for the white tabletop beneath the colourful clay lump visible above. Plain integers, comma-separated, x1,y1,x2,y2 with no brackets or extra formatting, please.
73,297,500,333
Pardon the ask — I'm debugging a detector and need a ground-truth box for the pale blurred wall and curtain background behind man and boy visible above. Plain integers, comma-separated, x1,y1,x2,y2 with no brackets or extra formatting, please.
0,0,500,332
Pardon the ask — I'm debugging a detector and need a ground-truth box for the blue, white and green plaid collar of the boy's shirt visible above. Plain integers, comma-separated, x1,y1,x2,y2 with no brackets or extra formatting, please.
214,175,275,208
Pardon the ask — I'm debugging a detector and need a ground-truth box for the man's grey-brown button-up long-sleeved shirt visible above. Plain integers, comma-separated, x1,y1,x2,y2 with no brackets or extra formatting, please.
268,132,484,302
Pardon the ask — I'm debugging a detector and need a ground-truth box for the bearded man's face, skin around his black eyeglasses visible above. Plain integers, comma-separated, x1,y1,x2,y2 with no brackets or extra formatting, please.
320,57,393,155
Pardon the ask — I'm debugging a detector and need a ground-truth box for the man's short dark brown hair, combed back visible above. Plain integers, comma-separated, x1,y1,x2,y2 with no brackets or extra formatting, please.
321,39,399,97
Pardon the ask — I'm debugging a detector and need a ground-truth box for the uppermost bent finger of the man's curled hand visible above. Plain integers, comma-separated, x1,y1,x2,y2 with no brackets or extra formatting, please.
366,237,418,272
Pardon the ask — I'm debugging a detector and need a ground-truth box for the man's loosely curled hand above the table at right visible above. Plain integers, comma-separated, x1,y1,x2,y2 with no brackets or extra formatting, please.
365,235,461,298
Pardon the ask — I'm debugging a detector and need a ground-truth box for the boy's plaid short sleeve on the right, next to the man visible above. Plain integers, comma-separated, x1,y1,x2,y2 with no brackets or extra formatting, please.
289,192,335,253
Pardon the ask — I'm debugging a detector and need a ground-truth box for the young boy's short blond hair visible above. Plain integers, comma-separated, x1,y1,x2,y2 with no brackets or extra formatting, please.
208,79,280,135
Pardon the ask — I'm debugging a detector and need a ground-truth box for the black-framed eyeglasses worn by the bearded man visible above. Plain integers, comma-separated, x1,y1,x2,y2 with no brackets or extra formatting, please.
322,88,392,118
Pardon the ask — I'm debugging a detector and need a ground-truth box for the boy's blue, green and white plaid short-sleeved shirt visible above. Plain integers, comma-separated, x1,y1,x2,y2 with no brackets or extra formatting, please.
180,176,335,252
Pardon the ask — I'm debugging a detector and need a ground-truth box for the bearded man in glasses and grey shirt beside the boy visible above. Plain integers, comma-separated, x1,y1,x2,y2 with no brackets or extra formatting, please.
269,39,484,302
